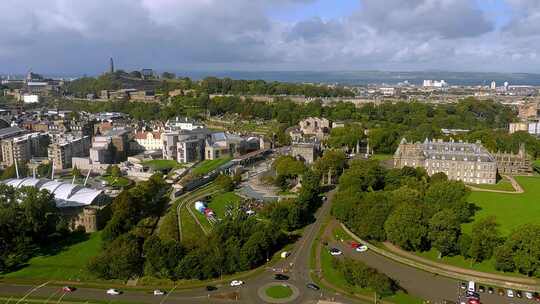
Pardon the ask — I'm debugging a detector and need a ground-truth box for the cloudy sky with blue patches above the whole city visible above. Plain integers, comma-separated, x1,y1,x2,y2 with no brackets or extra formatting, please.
0,0,540,74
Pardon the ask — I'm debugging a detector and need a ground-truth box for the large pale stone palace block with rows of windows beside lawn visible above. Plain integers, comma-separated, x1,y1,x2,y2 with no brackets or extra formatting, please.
394,138,497,184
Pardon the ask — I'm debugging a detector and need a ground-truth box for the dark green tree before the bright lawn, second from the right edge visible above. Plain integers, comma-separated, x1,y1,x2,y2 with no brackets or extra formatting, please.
469,216,503,262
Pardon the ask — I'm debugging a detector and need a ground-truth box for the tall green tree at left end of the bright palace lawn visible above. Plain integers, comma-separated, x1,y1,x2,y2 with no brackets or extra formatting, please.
428,209,461,256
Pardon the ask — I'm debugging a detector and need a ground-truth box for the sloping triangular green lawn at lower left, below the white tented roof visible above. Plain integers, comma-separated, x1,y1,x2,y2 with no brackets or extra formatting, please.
5,232,101,281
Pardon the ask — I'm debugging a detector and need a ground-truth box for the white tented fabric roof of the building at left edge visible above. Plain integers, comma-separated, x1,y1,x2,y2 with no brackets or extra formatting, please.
2,177,103,208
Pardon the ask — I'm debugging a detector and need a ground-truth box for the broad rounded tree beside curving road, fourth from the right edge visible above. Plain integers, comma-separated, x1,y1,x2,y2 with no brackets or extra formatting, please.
384,202,428,250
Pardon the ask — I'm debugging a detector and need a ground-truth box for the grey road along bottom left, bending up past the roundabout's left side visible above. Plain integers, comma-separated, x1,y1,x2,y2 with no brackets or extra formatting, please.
0,193,356,304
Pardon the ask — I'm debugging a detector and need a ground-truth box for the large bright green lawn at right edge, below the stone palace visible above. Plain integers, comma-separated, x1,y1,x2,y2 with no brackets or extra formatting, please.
463,176,540,235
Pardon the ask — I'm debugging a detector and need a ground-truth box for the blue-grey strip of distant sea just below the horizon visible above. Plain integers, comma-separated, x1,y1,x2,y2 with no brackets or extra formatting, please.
176,71,540,86
